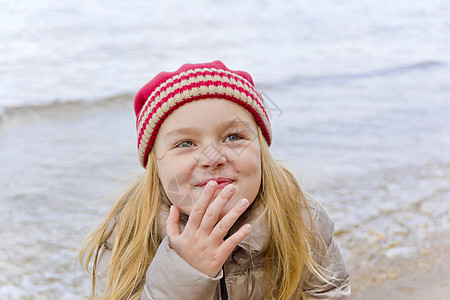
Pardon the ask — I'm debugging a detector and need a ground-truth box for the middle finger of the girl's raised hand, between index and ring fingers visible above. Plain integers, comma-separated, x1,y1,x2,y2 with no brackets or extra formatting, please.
200,184,236,234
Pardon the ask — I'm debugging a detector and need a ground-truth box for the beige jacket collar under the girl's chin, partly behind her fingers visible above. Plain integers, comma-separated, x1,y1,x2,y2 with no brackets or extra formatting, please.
159,205,270,253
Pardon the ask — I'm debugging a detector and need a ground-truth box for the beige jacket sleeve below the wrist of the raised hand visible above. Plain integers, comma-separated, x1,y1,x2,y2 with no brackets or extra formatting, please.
141,236,223,300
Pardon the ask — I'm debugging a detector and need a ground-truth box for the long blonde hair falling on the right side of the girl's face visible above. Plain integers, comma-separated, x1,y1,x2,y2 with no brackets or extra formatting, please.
258,131,331,300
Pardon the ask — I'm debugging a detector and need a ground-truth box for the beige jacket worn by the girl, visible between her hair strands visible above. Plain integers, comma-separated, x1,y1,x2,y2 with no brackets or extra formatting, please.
99,198,352,300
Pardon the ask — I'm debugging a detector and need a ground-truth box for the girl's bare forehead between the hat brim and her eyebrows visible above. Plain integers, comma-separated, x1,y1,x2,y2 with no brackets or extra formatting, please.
158,98,256,136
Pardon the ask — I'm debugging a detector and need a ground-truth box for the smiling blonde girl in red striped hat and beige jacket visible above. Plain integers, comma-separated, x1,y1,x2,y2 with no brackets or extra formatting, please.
80,61,351,300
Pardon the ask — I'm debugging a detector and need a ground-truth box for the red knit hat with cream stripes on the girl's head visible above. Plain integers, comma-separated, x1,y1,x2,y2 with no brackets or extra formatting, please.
134,60,272,168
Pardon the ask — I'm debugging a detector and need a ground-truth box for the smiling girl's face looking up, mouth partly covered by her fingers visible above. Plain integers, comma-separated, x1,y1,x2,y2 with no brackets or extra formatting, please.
154,98,261,218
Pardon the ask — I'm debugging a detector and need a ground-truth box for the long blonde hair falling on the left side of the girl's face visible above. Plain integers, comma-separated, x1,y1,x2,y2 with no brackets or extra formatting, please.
79,151,170,299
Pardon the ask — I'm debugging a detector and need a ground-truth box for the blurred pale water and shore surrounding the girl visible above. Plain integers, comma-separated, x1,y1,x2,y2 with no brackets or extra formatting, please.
0,0,450,299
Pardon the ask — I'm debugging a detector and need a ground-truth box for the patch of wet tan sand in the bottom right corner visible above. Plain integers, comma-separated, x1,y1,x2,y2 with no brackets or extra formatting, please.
350,231,450,300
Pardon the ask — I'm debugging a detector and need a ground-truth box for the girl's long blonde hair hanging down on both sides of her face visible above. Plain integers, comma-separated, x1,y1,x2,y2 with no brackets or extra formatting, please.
78,127,326,300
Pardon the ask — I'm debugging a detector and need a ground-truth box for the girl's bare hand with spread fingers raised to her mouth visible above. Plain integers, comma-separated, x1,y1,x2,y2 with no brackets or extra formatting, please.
166,181,251,277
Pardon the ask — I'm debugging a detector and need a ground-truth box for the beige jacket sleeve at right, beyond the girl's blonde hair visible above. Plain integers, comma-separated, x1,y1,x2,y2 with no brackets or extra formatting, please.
304,201,352,300
